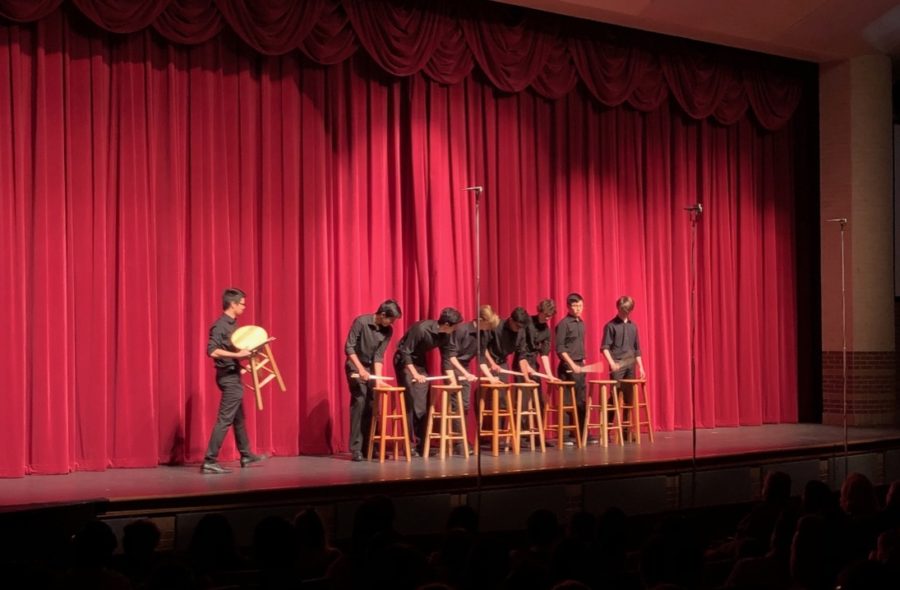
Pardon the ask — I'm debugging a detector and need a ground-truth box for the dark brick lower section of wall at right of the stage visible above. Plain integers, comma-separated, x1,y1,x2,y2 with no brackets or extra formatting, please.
822,350,897,426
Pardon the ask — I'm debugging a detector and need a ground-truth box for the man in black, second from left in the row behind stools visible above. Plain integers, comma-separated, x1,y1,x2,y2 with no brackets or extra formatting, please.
394,307,462,457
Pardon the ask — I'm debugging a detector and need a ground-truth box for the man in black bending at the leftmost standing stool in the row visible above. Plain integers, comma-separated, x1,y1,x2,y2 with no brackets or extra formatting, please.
344,299,403,461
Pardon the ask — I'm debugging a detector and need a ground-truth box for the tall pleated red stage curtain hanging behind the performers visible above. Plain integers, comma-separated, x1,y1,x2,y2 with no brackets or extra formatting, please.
0,0,804,476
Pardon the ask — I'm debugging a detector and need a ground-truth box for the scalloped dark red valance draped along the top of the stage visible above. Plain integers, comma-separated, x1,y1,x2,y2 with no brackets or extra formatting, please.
0,0,801,130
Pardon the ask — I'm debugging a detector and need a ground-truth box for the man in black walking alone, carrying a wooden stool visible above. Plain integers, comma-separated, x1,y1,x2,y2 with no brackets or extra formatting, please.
206,289,266,474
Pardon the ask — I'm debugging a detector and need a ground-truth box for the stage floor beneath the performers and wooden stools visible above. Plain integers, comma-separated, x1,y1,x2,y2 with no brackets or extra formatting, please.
0,424,900,511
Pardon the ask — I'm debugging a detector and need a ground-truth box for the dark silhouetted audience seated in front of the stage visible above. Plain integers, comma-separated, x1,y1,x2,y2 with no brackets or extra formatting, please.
2,472,900,590
